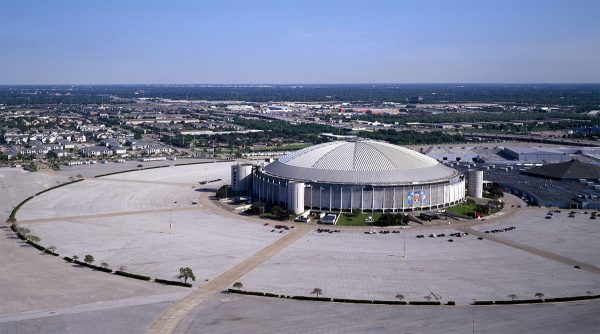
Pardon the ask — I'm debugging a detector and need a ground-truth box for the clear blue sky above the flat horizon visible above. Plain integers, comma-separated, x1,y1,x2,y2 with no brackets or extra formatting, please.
0,0,600,85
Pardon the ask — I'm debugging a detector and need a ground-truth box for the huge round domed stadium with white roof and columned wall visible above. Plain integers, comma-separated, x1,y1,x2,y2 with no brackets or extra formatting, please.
243,139,465,214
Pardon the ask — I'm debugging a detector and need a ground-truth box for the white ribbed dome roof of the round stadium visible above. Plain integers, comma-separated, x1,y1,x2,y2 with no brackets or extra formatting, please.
264,140,458,185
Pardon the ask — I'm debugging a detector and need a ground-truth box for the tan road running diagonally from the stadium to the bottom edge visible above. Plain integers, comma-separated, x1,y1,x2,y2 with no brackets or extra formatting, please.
146,226,312,334
